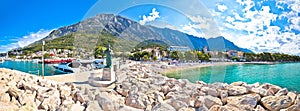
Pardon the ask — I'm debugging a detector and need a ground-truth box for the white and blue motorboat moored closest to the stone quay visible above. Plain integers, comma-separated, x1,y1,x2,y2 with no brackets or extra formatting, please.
53,62,81,74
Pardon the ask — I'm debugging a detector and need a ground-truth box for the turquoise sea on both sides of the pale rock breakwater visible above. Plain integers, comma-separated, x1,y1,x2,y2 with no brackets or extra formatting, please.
0,61,300,93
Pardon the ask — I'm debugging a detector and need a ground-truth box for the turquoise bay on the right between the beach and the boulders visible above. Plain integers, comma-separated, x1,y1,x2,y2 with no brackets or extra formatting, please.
167,63,300,92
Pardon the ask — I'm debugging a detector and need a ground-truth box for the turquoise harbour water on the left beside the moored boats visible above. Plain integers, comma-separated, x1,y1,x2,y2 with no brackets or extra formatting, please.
0,61,57,76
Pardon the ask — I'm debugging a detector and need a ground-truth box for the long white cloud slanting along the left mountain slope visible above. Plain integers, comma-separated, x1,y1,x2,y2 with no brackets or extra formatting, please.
0,29,52,52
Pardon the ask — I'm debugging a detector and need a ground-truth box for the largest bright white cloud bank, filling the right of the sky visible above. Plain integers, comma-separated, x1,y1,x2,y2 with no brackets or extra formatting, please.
215,0,300,55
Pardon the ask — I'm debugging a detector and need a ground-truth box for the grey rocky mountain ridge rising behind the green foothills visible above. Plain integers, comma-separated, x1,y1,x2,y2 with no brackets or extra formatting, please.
28,14,248,51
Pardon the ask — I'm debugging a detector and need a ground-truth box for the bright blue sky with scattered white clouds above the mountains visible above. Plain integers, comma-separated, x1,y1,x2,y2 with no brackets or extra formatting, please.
0,0,300,55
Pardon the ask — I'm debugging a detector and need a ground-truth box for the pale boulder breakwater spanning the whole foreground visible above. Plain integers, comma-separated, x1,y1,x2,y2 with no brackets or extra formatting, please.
0,64,300,111
